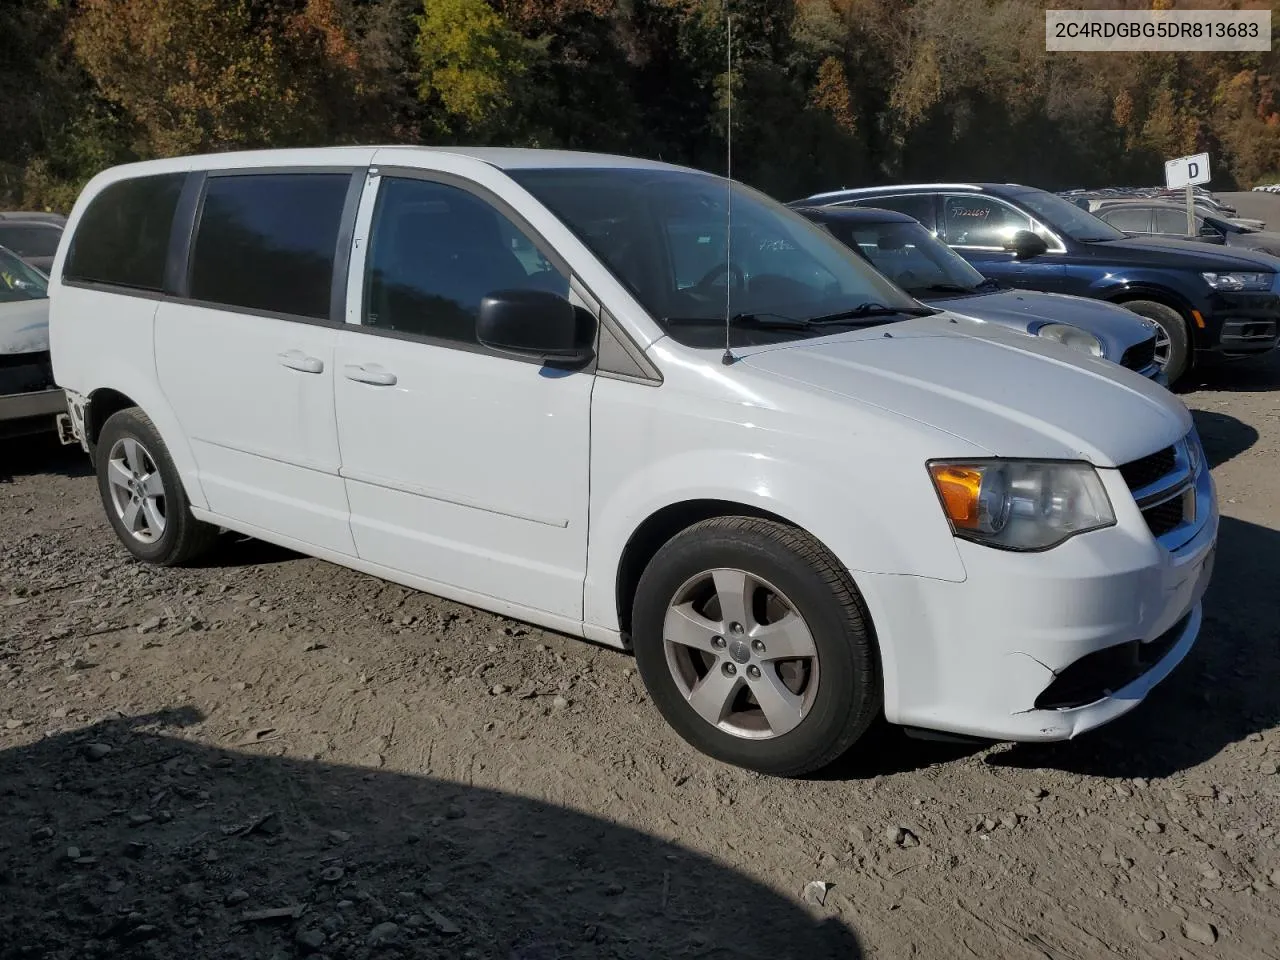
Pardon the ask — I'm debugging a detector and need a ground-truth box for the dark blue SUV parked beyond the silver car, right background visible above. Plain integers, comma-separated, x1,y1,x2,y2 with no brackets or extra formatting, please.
796,183,1280,384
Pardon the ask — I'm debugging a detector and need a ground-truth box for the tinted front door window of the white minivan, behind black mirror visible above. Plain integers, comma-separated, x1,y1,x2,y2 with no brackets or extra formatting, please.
365,177,568,343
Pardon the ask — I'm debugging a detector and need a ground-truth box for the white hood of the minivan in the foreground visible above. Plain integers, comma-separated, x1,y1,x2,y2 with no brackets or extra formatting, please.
740,314,1192,467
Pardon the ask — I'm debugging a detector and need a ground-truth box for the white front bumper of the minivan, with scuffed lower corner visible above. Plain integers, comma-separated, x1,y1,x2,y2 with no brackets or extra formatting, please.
859,450,1219,741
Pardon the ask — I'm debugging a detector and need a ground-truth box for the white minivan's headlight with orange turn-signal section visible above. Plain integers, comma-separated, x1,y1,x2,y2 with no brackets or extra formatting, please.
928,460,1116,550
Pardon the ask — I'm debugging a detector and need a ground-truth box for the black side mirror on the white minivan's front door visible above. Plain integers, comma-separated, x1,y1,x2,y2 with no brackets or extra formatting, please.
476,291,591,364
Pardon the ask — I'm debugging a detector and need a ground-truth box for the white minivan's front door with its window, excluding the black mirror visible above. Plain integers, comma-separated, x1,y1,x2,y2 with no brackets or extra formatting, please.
334,172,594,621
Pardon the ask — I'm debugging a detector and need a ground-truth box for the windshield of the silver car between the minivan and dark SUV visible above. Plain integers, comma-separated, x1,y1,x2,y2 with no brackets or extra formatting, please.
826,219,983,297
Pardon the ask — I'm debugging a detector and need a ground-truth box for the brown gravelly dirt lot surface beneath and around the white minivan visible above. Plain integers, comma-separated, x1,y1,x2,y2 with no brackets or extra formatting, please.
0,362,1280,960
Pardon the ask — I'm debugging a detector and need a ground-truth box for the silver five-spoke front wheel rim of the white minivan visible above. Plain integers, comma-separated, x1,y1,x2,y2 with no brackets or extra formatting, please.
663,568,818,740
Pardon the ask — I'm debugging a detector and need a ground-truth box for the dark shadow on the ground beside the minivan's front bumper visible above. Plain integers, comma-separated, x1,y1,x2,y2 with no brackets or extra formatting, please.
987,517,1280,778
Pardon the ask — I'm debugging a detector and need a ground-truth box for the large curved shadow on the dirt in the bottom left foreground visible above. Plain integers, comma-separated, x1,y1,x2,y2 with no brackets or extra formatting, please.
0,710,861,960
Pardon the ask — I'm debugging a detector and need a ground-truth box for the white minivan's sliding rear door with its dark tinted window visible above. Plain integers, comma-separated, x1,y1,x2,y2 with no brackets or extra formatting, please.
155,172,366,556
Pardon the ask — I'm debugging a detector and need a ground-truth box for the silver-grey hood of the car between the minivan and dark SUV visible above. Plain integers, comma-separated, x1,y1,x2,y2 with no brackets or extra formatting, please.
925,291,1155,361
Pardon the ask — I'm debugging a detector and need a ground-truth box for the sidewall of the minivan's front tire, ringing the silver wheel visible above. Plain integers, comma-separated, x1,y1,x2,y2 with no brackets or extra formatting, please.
632,530,879,776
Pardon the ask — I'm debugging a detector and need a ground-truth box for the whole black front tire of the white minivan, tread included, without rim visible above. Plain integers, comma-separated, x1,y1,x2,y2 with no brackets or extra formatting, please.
632,517,883,777
